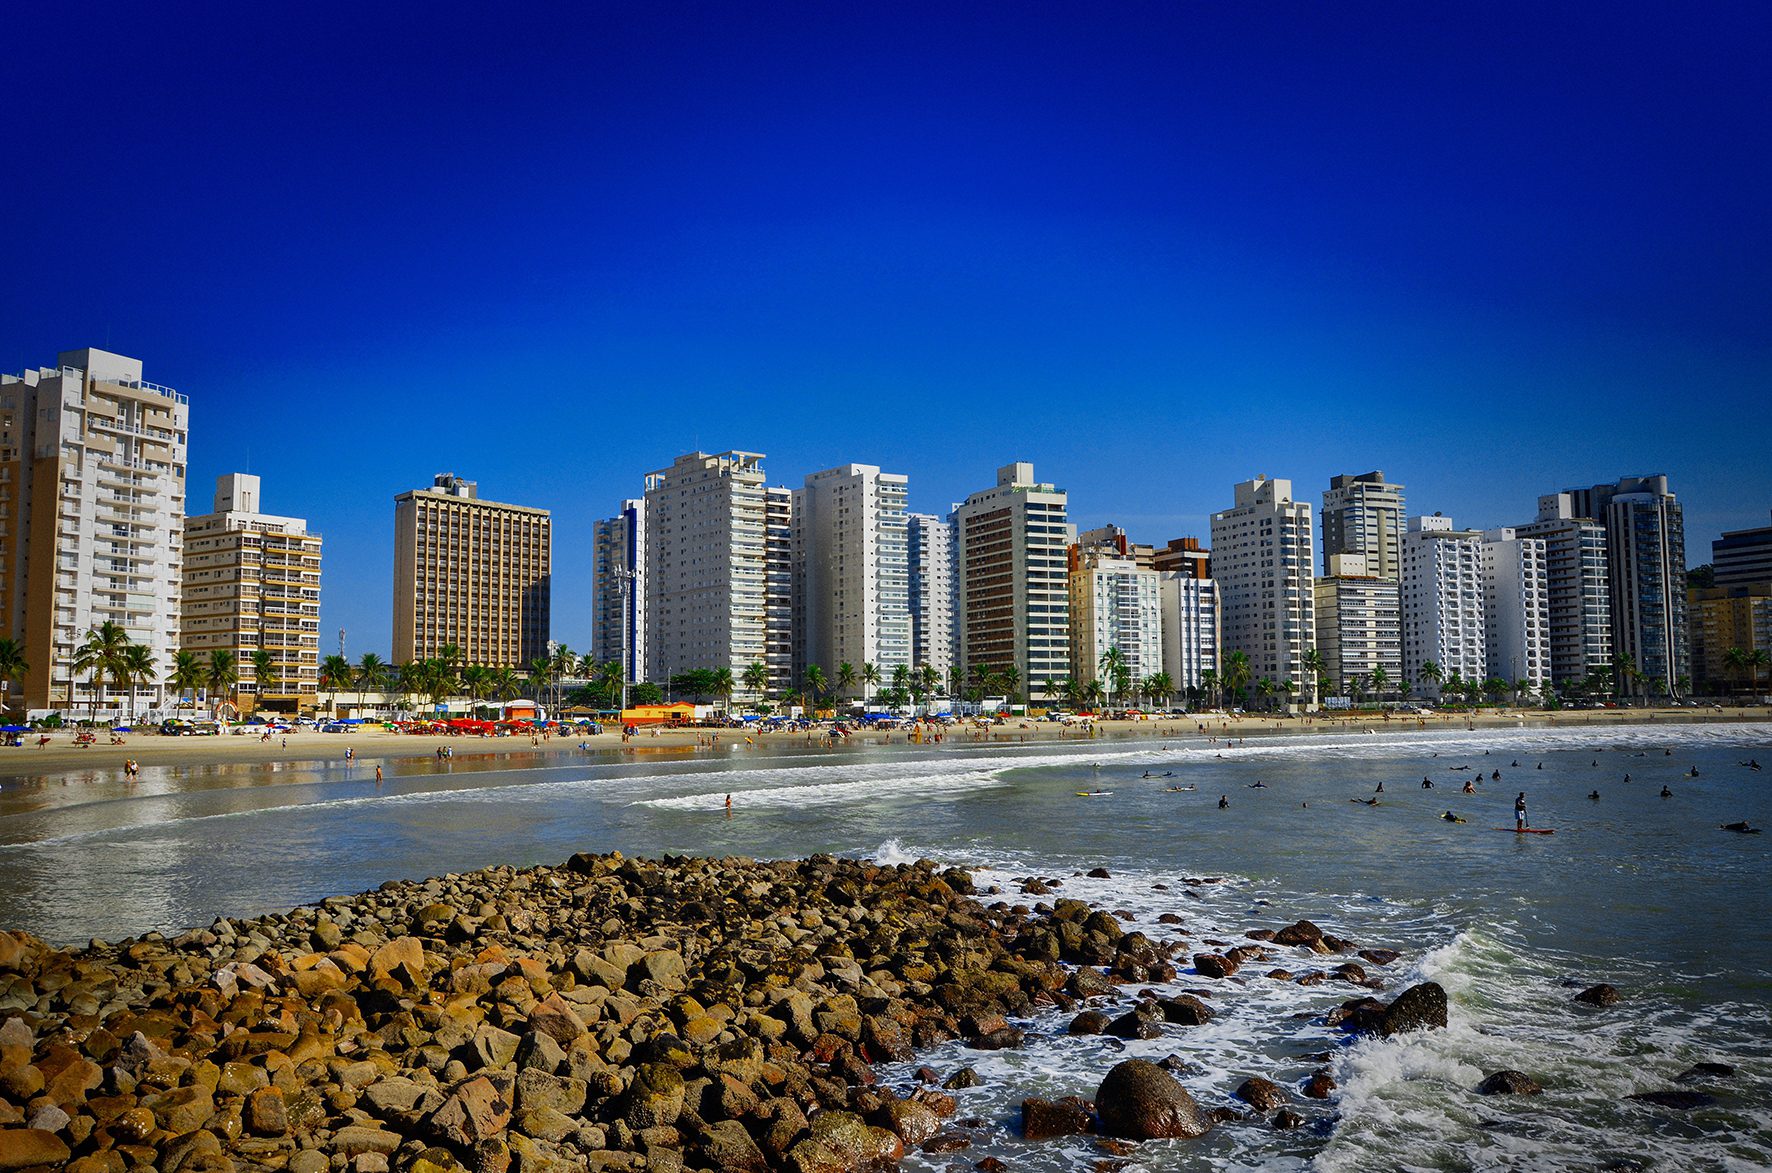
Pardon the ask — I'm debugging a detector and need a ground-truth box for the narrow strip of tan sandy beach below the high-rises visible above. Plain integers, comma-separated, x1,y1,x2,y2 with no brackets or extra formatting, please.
0,707,1768,780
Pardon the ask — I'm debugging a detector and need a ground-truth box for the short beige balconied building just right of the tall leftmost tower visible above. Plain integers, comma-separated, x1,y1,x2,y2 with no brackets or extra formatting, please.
183,473,321,712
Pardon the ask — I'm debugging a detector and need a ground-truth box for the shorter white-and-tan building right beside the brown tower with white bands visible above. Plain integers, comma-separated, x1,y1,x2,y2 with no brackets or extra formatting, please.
1069,537,1162,693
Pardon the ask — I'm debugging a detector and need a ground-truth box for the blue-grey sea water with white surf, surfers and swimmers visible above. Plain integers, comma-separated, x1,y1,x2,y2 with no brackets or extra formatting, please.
0,725,1772,1171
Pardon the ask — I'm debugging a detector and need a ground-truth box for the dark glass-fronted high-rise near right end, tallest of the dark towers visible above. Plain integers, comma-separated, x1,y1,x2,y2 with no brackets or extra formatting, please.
1570,475,1692,695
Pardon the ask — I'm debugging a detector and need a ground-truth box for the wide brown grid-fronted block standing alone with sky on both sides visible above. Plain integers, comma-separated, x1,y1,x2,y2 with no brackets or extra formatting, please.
393,473,553,668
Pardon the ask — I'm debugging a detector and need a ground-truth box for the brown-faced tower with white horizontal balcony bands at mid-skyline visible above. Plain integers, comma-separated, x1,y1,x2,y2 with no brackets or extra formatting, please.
953,461,1076,696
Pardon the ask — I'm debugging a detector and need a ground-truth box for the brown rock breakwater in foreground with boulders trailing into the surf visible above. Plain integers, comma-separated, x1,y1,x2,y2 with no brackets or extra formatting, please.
0,854,1446,1173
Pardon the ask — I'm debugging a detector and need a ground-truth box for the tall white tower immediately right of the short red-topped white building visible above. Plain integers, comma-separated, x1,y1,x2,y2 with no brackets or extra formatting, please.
1212,477,1317,698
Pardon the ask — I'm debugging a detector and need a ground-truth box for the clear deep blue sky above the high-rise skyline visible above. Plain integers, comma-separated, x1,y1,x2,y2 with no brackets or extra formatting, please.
0,0,1772,657
